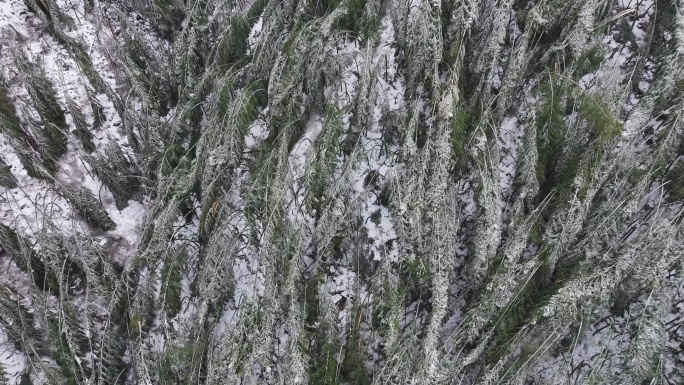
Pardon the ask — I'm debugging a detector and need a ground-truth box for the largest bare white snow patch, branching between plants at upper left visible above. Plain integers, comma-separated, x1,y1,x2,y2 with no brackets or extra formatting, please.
0,0,147,258
